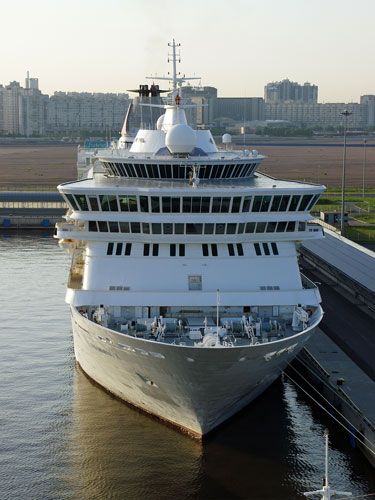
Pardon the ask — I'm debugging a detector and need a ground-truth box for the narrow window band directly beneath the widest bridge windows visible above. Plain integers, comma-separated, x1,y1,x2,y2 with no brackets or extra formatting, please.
89,220,306,235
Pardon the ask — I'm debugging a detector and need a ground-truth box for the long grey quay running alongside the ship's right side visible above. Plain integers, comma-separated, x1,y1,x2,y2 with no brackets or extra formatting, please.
294,230,375,467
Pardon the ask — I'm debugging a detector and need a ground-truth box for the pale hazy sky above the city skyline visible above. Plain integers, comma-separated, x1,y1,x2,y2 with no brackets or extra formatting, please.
0,0,375,102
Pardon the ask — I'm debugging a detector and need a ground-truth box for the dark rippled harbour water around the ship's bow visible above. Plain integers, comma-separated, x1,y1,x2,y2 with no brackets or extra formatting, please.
0,233,375,500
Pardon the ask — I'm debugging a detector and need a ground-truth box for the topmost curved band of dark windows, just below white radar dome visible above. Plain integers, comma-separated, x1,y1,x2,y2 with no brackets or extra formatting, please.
102,161,258,179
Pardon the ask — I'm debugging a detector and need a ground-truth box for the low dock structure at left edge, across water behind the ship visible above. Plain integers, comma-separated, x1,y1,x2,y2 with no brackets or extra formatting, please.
0,191,67,230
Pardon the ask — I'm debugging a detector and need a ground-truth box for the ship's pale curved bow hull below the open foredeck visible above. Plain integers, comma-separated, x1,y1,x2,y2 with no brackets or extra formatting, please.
71,307,316,438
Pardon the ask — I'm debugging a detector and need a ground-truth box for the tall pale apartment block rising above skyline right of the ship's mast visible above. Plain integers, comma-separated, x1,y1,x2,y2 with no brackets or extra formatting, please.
264,79,318,103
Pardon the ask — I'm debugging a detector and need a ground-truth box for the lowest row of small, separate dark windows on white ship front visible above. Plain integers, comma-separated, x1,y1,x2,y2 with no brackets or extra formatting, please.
107,243,279,257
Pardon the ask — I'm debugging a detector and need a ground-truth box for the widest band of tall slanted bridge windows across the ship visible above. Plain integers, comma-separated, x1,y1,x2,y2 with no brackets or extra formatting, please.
65,194,320,214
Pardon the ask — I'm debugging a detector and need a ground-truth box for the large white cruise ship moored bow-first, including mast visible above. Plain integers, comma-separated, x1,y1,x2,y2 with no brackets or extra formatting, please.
55,41,324,438
